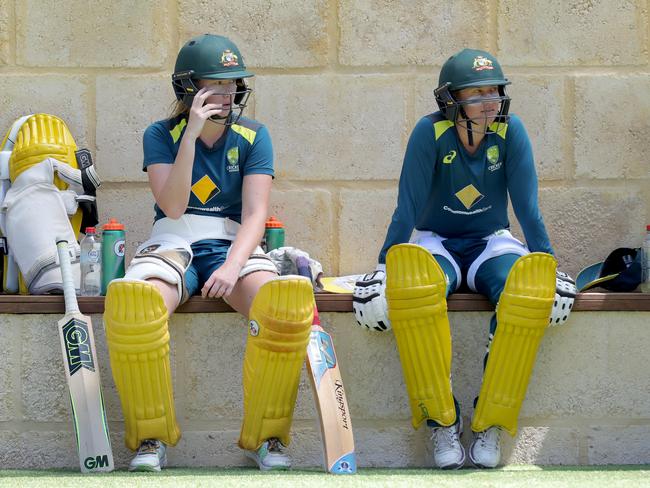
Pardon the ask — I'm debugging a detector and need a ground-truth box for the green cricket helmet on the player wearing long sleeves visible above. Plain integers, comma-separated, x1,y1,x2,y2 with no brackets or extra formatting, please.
434,49,510,134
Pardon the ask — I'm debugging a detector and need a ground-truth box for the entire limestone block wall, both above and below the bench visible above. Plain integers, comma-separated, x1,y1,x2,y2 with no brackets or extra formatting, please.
0,0,650,466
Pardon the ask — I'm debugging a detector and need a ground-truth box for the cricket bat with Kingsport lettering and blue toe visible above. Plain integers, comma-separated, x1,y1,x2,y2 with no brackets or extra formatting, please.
296,257,357,474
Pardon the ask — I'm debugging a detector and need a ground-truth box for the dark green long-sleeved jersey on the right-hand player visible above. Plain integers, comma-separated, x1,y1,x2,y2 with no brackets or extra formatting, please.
379,112,553,263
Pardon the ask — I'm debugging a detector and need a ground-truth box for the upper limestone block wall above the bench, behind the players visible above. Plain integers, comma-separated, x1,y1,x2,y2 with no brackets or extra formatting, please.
0,0,650,274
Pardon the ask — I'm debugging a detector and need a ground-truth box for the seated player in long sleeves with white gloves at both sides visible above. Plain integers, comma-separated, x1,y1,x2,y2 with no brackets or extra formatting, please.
353,49,575,469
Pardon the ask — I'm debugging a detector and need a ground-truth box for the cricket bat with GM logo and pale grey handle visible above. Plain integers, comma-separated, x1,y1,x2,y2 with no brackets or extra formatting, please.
56,239,114,473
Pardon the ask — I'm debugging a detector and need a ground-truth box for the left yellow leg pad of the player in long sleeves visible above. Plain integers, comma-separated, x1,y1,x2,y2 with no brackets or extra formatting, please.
386,244,456,428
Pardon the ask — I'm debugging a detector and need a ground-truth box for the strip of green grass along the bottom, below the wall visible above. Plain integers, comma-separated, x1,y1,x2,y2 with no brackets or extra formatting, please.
0,465,650,488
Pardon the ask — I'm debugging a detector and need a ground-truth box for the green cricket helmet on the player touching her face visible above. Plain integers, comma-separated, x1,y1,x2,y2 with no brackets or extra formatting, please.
172,34,254,125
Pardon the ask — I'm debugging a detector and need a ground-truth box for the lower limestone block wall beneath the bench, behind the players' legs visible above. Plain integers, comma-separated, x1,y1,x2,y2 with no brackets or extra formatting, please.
0,312,650,468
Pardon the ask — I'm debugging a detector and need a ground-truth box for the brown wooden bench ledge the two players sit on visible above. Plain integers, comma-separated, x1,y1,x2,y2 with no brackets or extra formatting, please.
0,293,650,314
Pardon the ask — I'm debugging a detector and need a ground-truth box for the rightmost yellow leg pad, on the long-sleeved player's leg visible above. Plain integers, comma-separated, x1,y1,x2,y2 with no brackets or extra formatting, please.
472,252,557,436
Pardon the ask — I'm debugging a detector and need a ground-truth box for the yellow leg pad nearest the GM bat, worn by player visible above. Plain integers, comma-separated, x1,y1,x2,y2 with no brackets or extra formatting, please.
104,281,181,450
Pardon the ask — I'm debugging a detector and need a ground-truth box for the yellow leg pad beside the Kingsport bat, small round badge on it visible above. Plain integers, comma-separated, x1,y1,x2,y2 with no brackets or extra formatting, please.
239,276,314,450
